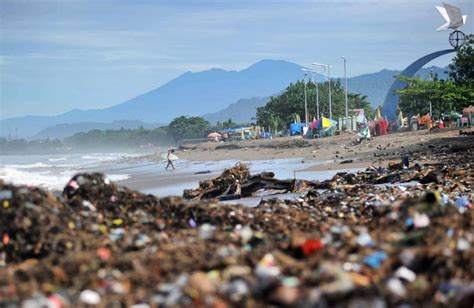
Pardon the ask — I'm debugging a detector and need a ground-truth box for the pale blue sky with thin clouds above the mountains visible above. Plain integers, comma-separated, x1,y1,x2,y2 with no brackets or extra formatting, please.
0,0,474,118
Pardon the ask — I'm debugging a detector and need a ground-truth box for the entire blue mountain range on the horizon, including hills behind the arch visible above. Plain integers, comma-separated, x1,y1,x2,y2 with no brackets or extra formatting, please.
0,60,447,138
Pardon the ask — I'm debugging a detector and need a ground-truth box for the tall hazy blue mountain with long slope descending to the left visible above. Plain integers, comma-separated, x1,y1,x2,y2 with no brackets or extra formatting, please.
0,60,308,137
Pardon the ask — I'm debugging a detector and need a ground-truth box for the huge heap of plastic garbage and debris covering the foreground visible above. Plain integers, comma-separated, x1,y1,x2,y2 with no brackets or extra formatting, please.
0,144,474,307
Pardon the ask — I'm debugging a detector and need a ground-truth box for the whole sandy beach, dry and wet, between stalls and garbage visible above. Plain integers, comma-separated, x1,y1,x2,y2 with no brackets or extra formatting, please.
118,129,470,196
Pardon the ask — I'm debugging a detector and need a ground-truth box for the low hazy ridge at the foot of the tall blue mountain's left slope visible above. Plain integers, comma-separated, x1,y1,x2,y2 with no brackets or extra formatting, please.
33,121,162,139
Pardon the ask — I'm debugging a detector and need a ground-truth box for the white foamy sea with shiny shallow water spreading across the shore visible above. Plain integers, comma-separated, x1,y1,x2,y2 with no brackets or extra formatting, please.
0,150,364,196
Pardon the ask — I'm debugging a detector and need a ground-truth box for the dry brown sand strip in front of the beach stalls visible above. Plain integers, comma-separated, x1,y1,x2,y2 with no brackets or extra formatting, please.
161,129,459,163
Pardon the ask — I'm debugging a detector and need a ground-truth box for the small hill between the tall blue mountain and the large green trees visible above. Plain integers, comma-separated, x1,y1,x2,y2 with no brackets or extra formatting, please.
202,96,270,124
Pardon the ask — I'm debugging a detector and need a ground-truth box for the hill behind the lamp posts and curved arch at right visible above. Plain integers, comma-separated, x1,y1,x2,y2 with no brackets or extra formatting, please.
341,66,448,107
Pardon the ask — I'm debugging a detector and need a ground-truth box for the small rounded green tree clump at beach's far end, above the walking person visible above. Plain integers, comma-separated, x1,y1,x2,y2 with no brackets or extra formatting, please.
168,116,211,141
